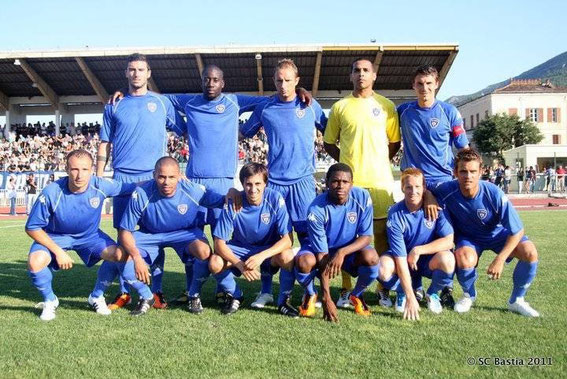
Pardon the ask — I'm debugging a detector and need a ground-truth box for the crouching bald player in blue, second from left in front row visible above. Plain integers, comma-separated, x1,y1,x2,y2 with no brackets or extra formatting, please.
118,157,236,316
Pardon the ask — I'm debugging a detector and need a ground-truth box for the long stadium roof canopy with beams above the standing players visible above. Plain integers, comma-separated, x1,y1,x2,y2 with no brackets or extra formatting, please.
0,44,458,109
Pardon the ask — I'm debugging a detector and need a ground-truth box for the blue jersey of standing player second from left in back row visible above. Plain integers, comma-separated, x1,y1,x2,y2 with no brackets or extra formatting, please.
166,94,267,178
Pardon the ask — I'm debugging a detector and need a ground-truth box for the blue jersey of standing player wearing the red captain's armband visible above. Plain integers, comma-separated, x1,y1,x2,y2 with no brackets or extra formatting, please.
398,100,469,183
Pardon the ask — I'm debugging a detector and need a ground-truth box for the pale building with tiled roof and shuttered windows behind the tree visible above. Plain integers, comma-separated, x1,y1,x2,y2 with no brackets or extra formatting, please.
457,79,567,170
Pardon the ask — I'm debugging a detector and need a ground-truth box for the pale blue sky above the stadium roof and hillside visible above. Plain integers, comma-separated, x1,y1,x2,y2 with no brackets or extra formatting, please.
0,0,567,99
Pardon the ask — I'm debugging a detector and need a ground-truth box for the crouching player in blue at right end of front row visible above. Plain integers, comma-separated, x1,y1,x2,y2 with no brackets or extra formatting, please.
433,149,539,317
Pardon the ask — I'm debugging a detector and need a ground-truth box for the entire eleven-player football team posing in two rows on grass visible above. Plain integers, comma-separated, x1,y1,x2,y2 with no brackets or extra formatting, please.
25,54,539,322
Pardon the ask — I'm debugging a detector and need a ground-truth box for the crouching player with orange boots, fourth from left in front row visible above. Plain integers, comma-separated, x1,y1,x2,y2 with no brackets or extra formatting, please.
295,163,378,322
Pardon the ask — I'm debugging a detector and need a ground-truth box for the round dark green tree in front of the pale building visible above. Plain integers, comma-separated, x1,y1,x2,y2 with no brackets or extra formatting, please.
473,113,543,158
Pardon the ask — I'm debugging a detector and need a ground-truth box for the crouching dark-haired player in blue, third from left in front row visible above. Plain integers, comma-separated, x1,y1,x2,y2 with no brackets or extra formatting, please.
209,163,298,317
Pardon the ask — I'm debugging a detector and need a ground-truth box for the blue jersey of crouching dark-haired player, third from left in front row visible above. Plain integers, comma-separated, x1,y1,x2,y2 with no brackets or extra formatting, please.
213,188,291,247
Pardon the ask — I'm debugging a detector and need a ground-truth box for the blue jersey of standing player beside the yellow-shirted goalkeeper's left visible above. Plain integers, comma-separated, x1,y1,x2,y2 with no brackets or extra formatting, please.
240,96,327,185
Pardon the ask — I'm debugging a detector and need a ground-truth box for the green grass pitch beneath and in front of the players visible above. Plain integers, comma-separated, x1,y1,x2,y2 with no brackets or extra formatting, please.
0,211,567,378
